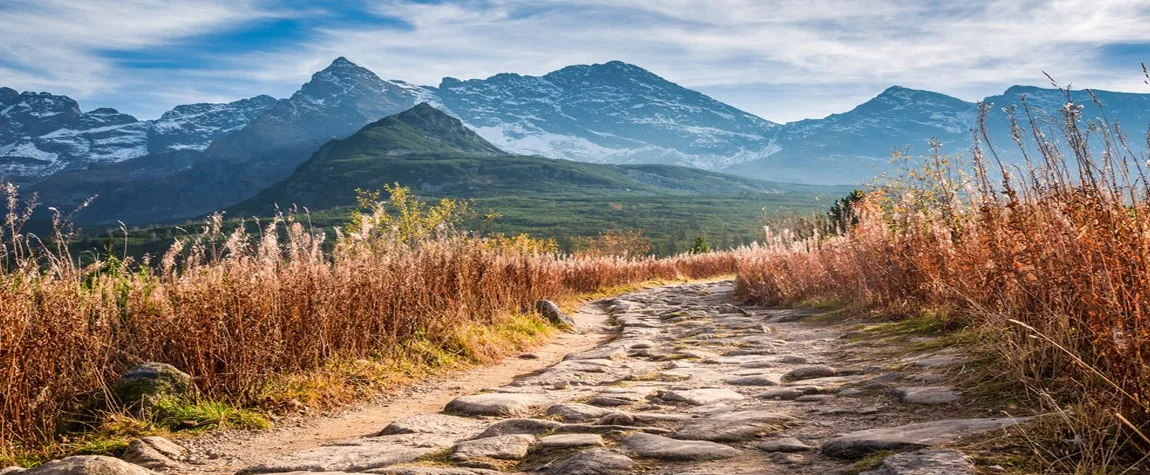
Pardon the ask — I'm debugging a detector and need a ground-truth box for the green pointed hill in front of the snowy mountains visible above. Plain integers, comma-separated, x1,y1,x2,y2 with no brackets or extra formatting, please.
229,104,809,215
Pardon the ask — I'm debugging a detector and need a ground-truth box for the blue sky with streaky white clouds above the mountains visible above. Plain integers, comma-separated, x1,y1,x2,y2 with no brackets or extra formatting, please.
0,0,1150,122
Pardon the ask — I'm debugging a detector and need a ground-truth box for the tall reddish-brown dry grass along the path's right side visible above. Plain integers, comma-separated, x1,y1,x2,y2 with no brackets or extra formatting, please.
738,85,1150,469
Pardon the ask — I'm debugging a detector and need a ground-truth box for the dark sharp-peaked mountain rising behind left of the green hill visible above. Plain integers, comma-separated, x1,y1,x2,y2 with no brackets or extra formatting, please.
32,58,437,223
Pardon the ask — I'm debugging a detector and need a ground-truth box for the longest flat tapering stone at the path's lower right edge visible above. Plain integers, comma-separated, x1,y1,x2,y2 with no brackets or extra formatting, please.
819,417,1025,459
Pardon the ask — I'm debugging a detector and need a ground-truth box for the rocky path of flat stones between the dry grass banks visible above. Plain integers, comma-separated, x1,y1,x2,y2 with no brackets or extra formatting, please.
173,281,1020,475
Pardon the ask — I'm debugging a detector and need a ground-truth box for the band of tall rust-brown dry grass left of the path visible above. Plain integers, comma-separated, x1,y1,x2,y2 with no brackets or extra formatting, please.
0,186,736,455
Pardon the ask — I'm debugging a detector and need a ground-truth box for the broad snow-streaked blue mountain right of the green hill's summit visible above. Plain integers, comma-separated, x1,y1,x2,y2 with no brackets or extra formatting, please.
438,61,777,169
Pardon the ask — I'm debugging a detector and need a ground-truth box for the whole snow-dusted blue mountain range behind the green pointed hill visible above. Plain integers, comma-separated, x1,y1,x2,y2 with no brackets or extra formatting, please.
0,58,1150,223
